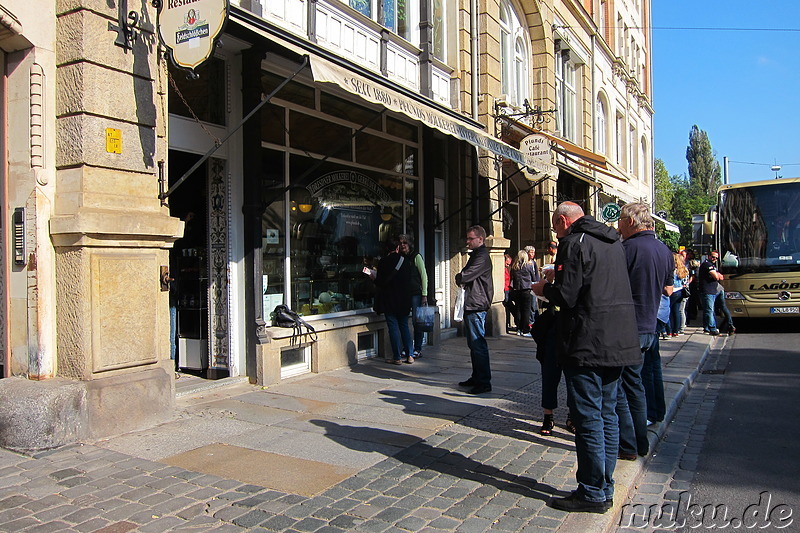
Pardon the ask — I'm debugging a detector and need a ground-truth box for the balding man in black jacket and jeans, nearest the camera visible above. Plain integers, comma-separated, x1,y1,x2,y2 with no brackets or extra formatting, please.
533,202,641,513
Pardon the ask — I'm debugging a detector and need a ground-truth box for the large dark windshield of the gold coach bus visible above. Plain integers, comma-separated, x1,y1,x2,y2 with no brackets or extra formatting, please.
718,182,800,274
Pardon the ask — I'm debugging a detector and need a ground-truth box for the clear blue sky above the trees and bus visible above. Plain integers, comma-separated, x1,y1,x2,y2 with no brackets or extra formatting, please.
652,0,800,183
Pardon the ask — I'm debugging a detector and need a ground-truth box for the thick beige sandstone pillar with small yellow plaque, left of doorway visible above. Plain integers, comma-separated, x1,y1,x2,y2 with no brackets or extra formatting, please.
50,0,183,437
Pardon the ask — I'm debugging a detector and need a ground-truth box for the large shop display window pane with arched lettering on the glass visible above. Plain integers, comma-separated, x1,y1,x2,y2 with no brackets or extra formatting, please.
289,156,417,315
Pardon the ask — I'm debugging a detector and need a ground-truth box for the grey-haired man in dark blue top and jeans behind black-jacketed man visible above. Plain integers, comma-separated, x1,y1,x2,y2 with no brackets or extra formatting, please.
617,202,675,460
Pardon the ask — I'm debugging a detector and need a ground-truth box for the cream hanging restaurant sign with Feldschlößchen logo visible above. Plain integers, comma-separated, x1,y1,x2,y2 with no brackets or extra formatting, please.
158,0,228,70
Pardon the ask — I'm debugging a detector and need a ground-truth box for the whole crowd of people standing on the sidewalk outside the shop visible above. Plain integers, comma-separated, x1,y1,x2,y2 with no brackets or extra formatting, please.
375,202,736,513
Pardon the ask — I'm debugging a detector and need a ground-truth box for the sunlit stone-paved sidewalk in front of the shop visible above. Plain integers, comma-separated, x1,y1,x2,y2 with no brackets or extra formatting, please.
0,326,710,533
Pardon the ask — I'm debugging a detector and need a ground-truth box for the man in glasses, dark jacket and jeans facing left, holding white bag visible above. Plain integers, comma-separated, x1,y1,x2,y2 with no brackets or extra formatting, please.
456,226,494,394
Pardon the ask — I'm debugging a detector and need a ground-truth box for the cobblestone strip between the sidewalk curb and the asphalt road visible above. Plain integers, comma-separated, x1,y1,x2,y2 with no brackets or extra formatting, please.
616,338,730,533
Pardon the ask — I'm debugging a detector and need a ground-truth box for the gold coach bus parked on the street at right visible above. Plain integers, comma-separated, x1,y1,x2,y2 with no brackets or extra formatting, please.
711,178,800,318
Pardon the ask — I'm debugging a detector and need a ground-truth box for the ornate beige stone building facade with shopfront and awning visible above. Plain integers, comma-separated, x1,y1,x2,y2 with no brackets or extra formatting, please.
0,0,652,449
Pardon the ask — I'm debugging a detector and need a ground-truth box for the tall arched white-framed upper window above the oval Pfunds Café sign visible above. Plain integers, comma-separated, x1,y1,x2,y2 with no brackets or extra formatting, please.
500,0,530,106
